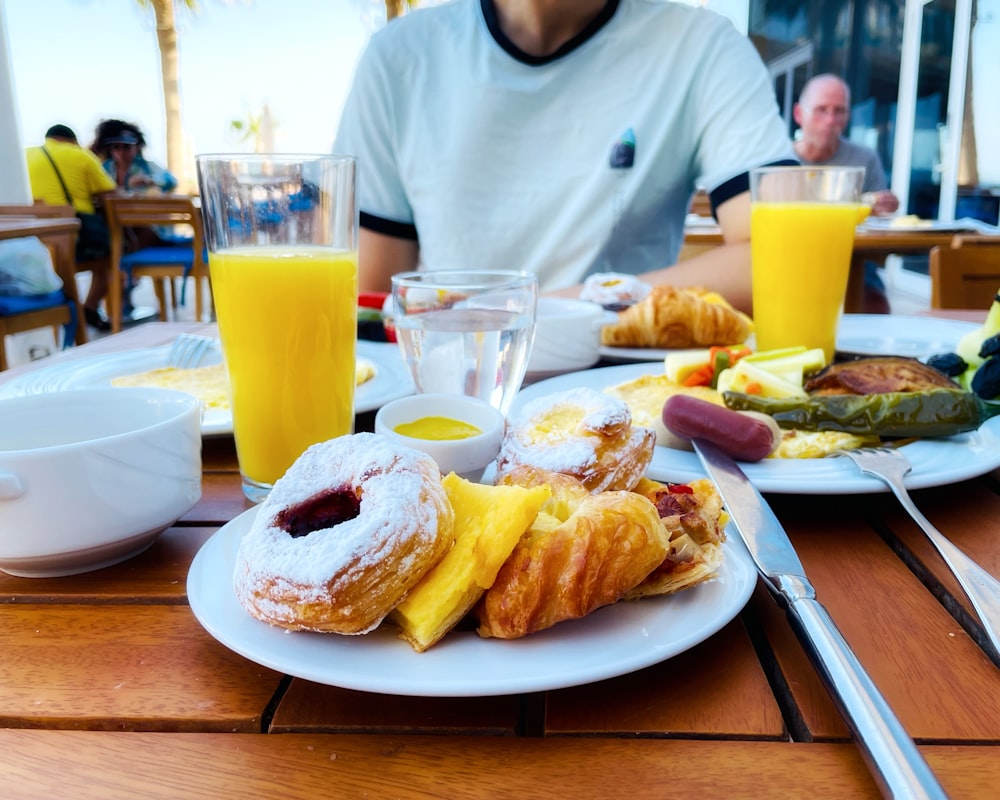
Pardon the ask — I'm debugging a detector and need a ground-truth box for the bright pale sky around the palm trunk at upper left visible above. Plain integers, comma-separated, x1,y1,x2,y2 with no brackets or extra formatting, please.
0,0,376,165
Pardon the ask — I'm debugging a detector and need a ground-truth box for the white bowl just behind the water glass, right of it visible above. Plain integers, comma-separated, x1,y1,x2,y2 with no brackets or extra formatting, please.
528,297,618,379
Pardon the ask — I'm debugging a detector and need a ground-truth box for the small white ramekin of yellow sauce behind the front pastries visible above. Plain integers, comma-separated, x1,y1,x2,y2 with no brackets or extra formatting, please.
375,394,507,481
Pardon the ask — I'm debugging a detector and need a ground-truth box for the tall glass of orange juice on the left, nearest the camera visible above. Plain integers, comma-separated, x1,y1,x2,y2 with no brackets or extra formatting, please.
197,154,358,502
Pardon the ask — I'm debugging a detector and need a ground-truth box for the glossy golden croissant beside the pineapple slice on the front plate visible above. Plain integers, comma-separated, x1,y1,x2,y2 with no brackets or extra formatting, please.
476,467,668,639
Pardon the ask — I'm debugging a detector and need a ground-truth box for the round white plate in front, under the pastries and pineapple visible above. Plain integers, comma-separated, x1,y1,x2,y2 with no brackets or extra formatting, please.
187,508,757,697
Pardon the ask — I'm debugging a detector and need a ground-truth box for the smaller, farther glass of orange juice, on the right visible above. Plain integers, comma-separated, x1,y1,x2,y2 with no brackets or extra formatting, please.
750,166,868,363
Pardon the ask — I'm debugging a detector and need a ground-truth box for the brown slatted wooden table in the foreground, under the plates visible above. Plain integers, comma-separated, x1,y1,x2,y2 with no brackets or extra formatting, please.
0,322,1000,800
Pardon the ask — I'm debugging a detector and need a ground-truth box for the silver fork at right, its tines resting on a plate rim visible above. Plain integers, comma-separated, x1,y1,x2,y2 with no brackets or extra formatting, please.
837,447,1000,655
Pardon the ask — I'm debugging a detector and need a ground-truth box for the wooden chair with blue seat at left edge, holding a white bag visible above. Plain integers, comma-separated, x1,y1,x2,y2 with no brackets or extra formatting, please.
0,222,87,371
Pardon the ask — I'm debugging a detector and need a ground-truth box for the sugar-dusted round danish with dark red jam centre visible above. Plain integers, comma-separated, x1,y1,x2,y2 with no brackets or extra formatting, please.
233,433,454,634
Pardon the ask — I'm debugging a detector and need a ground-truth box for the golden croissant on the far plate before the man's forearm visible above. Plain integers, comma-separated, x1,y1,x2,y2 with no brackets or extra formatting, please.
601,285,753,350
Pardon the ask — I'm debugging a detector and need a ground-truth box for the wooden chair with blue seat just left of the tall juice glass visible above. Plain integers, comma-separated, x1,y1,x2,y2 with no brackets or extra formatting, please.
104,195,212,332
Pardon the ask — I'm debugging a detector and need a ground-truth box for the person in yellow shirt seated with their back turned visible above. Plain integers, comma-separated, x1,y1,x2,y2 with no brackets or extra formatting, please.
25,125,117,331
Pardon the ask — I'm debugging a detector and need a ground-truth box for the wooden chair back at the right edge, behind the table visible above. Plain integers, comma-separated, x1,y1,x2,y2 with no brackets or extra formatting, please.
930,236,1000,309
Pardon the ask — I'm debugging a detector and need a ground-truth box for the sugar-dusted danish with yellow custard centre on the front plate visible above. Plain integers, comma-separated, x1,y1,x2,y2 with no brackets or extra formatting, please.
497,388,656,492
